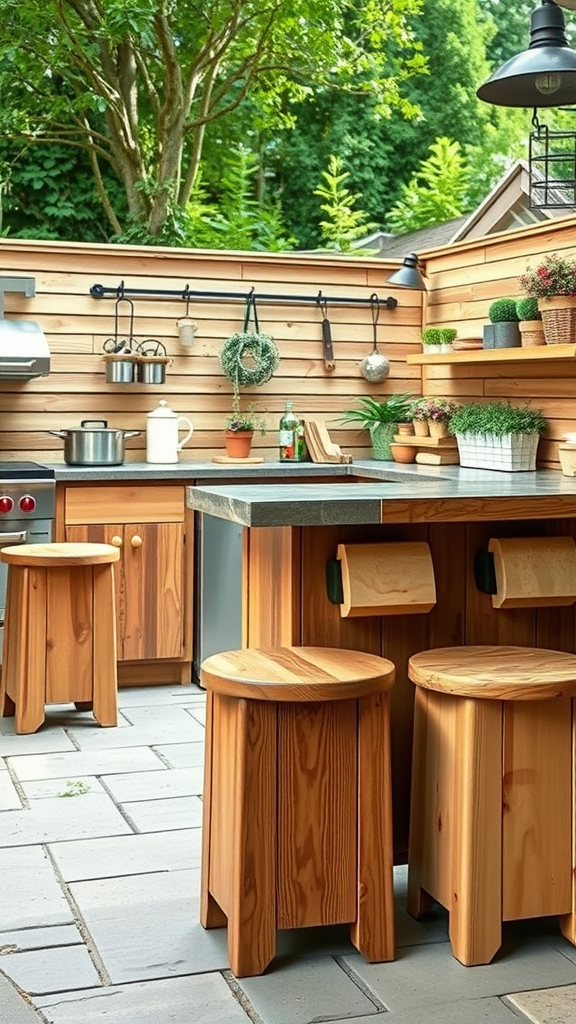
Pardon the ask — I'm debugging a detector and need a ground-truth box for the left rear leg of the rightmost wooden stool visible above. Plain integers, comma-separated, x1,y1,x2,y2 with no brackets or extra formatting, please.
406,686,434,919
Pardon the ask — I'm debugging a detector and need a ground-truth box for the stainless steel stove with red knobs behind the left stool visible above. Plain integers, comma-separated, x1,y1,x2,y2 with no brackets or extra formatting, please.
0,462,55,660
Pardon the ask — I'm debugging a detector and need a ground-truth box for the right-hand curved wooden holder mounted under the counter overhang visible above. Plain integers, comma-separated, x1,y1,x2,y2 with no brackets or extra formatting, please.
488,537,576,608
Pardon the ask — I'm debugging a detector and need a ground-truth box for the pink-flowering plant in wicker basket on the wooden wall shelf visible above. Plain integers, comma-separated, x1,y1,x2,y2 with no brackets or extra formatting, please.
520,253,576,345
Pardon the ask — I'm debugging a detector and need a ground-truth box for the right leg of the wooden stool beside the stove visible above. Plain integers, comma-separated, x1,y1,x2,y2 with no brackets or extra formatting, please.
92,564,118,726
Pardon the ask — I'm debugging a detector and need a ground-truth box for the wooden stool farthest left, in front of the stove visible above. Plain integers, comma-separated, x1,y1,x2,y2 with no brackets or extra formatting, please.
0,544,120,733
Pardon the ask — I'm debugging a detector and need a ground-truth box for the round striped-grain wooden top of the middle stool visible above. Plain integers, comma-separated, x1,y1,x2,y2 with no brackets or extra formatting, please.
200,647,396,701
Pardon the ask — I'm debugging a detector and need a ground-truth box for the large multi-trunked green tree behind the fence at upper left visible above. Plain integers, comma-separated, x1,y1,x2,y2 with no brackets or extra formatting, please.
0,0,421,238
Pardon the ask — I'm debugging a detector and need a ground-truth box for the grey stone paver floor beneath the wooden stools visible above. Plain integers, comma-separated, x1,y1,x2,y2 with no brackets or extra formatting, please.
0,686,576,1024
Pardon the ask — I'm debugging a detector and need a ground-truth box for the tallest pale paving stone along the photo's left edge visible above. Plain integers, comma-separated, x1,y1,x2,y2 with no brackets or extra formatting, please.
0,843,74,944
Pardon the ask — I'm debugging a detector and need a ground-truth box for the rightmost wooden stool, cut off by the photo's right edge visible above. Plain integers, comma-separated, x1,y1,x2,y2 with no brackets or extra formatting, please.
408,647,576,966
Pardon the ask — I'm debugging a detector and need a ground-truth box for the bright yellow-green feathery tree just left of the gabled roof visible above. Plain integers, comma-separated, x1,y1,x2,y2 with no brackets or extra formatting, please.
386,136,468,234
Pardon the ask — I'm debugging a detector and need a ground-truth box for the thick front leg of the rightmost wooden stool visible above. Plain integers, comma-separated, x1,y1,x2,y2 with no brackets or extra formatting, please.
448,697,502,967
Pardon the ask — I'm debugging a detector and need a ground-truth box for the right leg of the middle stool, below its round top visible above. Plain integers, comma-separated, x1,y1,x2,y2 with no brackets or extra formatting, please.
351,693,396,964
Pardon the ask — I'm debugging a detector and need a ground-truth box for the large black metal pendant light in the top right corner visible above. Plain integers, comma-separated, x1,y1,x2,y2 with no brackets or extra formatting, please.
477,0,576,106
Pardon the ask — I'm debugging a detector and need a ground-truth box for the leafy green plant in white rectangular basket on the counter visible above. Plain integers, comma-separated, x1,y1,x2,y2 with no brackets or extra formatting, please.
450,401,545,472
